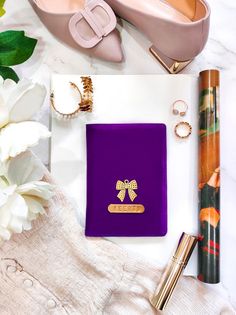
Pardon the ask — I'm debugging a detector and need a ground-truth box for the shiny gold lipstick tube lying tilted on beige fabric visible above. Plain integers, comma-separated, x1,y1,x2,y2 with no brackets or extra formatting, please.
150,233,198,311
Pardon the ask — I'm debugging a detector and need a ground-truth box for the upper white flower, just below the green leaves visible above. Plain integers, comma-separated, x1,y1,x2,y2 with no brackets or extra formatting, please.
0,78,50,162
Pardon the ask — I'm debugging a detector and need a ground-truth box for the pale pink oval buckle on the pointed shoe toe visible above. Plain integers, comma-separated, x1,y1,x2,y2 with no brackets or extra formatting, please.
69,0,116,48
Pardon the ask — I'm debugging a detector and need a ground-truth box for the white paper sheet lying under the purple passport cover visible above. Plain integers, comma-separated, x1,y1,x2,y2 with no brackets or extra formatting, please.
51,75,198,275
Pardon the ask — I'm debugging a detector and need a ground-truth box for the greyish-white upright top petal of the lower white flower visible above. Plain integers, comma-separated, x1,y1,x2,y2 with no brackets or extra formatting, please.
7,151,44,186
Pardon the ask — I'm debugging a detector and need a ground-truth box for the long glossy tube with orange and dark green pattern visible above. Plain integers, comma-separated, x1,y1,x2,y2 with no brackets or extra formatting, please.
198,70,220,283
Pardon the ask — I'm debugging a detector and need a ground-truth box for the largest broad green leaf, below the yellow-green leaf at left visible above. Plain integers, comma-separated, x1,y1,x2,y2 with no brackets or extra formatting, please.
0,31,37,66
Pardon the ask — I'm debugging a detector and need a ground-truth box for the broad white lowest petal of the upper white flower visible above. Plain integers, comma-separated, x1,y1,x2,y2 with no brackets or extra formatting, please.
0,121,51,162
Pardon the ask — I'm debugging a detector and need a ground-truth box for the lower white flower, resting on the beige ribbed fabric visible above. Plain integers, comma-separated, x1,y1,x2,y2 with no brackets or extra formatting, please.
0,151,53,240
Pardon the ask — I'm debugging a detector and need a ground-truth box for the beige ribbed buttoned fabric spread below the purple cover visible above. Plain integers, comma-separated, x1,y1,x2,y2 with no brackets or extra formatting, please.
0,162,236,315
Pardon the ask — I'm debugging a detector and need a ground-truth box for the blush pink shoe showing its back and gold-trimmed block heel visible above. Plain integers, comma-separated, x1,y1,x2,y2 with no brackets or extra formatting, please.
106,0,210,74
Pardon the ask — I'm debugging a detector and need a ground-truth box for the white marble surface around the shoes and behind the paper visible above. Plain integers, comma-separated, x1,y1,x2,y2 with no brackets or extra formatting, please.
0,0,236,307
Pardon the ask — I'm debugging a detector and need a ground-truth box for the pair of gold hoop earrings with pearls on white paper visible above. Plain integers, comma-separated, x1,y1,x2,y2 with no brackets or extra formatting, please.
50,77,93,120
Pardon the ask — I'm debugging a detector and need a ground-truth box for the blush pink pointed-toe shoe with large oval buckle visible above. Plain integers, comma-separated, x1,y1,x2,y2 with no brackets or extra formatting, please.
29,0,123,62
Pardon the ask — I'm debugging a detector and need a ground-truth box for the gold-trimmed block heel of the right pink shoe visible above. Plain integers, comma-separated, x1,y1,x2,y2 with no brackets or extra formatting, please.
149,45,192,74
